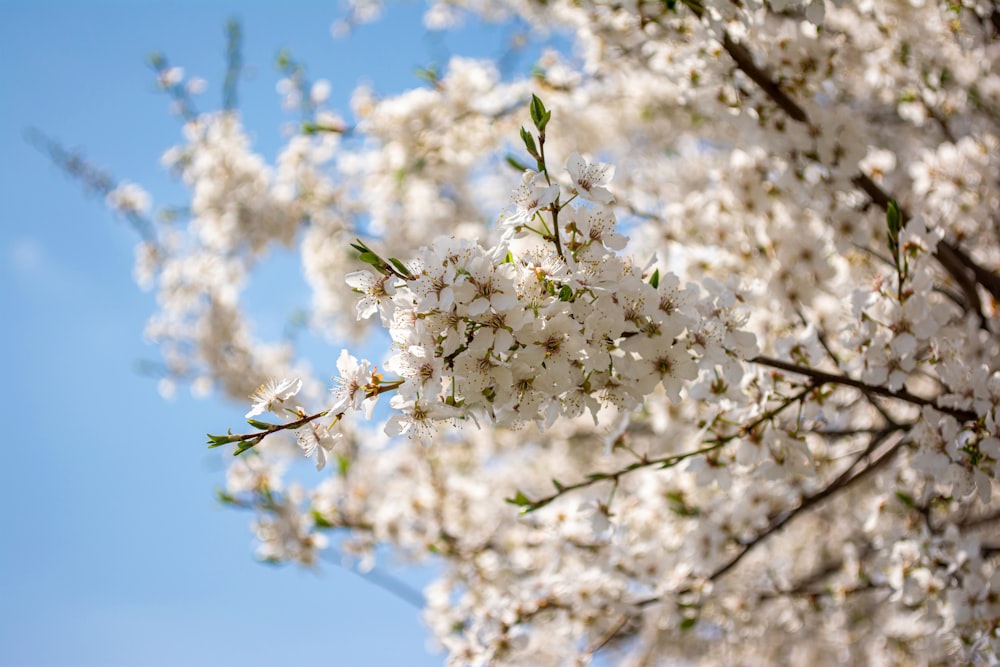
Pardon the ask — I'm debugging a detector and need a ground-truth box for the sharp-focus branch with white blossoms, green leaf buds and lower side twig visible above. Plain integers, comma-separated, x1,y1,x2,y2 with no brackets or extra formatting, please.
209,95,975,511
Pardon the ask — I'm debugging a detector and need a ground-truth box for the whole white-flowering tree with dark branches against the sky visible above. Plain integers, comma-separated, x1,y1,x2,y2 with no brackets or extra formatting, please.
56,0,1000,665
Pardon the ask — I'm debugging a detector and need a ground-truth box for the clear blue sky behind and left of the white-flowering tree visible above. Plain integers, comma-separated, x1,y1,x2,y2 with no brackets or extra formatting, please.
0,0,530,667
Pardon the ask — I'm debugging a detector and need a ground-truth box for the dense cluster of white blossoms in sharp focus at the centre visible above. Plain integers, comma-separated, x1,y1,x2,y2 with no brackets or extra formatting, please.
332,154,756,435
